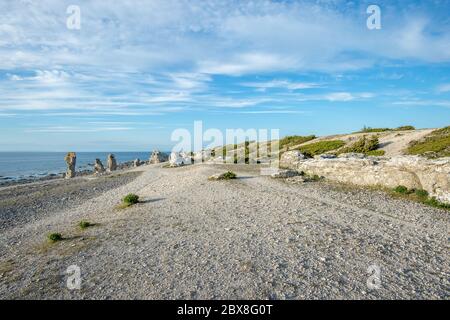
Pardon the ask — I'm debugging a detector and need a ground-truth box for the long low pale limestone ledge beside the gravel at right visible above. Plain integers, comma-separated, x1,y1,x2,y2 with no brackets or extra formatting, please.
282,151,450,203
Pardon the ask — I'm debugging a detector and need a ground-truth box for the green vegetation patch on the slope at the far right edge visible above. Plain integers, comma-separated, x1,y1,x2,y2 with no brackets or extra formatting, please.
406,126,450,158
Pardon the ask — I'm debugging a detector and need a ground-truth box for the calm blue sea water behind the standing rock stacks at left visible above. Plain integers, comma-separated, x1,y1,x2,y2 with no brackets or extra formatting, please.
0,152,151,181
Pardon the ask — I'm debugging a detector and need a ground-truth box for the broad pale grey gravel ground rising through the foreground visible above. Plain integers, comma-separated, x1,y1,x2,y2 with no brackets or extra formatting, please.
0,165,450,299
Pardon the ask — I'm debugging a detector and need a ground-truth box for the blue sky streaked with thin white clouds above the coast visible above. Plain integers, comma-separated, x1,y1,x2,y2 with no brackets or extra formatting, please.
0,0,450,151
